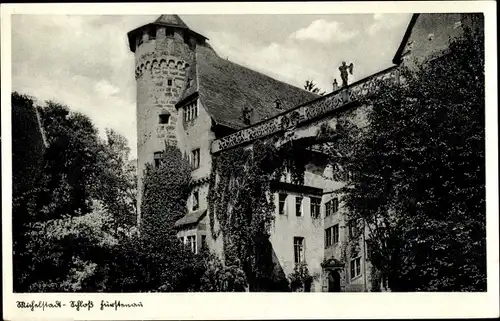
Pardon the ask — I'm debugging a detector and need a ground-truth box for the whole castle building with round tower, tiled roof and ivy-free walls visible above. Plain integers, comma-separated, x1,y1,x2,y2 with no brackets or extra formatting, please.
128,14,480,292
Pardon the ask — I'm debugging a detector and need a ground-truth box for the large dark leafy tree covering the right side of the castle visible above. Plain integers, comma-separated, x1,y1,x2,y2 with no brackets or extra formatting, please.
331,30,486,291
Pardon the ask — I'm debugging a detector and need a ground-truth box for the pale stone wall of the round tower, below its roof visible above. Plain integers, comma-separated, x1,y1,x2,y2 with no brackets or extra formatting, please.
135,28,194,220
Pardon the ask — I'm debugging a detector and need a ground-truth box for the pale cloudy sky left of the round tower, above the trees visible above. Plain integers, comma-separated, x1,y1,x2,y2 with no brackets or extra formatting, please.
12,15,137,155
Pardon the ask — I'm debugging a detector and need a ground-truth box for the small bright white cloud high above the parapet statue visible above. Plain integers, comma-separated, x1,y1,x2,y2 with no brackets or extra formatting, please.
290,19,359,43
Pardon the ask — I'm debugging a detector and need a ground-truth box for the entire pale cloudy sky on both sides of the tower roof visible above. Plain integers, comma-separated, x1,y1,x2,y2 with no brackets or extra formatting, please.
12,13,411,157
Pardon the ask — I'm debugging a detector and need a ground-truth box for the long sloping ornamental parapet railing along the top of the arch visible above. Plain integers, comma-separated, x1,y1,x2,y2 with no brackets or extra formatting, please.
212,66,399,154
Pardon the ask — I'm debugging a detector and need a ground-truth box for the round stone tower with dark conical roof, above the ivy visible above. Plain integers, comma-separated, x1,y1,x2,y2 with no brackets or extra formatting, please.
128,15,206,223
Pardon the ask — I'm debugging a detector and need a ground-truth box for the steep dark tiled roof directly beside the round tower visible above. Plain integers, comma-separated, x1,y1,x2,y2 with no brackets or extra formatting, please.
176,45,319,130
